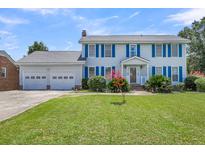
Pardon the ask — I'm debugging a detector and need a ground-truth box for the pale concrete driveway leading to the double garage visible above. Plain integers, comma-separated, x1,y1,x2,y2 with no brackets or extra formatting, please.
0,90,69,121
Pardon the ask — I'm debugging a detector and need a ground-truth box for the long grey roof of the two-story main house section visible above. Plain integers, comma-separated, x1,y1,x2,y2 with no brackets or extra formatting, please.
79,35,190,43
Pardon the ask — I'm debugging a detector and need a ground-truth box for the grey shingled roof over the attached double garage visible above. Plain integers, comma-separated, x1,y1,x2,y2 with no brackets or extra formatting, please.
17,51,85,64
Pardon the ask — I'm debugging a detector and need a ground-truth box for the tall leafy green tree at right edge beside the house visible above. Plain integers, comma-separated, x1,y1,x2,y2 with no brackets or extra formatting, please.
178,17,205,73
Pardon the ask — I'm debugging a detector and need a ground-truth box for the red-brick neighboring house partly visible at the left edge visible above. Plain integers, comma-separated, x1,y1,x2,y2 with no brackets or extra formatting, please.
0,50,19,90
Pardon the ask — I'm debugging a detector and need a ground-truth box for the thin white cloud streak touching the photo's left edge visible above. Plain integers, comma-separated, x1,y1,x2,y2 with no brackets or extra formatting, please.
0,16,29,25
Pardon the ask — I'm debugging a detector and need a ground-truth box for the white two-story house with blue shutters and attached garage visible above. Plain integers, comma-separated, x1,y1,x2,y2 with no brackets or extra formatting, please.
18,30,189,89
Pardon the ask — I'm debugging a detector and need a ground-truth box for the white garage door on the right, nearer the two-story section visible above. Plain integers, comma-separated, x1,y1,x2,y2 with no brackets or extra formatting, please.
50,72,75,90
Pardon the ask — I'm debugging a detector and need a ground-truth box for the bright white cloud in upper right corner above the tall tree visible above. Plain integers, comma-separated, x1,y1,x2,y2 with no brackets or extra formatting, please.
165,9,205,26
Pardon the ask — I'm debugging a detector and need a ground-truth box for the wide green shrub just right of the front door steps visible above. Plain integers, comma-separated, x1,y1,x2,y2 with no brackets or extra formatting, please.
144,75,172,93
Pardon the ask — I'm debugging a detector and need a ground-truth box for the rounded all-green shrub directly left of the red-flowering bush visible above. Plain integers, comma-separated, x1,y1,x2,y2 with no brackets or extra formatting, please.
88,76,106,92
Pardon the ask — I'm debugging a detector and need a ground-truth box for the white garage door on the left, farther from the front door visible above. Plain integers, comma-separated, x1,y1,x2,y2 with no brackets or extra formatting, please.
23,72,47,90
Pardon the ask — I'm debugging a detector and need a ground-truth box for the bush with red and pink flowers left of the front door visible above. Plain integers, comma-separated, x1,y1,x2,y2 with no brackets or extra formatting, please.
107,76,130,93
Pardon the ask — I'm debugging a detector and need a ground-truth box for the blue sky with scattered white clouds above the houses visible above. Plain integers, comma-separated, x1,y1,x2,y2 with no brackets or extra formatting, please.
0,8,205,60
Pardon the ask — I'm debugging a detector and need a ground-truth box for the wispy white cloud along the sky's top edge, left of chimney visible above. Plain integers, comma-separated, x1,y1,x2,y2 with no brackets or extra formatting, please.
22,8,59,16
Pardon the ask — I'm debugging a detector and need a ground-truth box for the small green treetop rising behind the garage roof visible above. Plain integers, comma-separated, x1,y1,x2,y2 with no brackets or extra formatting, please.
28,41,48,54
